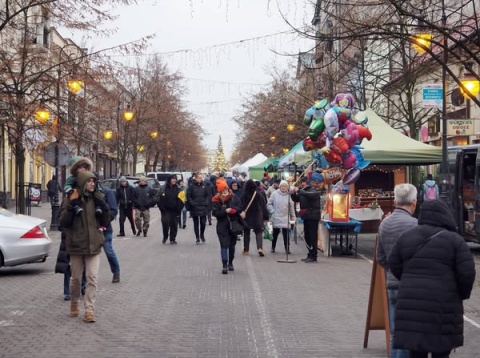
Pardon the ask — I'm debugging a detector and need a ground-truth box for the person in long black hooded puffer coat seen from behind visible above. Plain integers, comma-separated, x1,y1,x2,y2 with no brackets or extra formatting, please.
388,200,475,358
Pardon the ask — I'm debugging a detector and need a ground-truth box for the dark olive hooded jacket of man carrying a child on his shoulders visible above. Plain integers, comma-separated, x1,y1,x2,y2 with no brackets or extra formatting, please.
60,171,110,255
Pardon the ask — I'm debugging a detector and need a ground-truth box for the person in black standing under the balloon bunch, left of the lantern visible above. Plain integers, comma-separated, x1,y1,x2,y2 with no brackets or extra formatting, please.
291,181,321,263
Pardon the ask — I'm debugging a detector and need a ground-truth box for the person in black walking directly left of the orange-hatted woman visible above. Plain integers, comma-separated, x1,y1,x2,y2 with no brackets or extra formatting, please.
187,173,212,245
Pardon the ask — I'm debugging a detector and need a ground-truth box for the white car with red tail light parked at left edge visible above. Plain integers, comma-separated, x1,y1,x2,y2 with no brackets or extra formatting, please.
0,209,52,267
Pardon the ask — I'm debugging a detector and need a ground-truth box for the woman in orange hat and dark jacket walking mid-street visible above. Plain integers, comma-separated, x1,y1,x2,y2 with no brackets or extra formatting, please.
212,179,242,274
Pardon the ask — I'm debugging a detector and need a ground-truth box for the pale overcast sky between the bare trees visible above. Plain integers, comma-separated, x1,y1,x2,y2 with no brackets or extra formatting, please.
87,0,314,157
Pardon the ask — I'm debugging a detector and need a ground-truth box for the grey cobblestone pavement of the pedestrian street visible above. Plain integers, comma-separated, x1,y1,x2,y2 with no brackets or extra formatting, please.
0,204,480,358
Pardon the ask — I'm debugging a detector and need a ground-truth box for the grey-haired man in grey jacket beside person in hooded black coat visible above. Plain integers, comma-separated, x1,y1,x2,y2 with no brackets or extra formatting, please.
376,184,417,358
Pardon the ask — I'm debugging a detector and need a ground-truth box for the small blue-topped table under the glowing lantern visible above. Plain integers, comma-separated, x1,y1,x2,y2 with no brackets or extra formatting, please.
322,219,362,257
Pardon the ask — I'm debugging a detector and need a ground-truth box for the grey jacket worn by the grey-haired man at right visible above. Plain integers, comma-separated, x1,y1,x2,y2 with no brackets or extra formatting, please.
377,208,417,289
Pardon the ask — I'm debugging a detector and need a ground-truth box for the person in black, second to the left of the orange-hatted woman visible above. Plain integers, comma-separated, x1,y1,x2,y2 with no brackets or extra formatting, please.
157,174,184,245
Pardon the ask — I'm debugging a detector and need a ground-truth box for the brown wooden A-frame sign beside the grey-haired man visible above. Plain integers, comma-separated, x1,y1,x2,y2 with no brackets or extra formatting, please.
363,235,390,356
